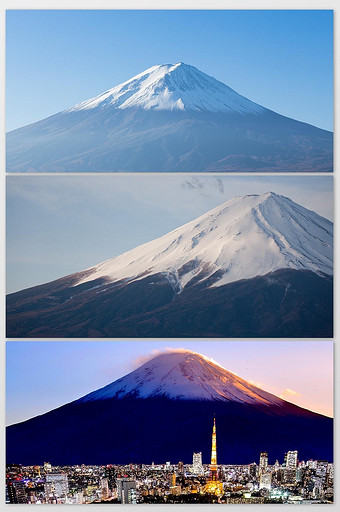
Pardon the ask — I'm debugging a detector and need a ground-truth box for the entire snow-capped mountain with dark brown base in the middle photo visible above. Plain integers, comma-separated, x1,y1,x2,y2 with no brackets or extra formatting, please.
7,192,333,338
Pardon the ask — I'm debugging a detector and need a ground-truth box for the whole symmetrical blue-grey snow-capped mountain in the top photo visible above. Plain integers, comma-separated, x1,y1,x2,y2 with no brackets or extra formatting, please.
7,63,333,172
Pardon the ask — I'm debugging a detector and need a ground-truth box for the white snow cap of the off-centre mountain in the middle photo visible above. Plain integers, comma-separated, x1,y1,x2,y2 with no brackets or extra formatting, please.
75,192,333,293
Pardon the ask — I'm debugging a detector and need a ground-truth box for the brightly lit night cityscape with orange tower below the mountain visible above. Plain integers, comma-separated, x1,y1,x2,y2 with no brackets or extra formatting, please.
6,418,334,504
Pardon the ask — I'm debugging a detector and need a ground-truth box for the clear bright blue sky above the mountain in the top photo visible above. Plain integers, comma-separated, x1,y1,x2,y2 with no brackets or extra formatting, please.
6,10,333,131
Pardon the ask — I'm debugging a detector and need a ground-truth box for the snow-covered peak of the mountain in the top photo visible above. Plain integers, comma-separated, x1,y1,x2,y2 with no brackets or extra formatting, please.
65,62,266,114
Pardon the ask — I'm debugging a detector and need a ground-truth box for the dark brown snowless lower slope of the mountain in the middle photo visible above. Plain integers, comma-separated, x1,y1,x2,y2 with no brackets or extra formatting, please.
7,269,333,338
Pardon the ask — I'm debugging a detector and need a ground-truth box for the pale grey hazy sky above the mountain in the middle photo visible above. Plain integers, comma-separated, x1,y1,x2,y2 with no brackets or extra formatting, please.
7,174,333,293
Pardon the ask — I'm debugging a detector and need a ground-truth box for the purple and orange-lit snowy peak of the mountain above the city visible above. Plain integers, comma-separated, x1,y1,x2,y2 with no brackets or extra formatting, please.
79,350,285,405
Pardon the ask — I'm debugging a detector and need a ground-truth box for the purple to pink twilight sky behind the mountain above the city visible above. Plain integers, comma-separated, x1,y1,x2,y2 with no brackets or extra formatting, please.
6,340,333,424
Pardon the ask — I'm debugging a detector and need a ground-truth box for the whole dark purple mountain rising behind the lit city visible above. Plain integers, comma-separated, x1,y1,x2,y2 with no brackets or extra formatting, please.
6,350,333,465
